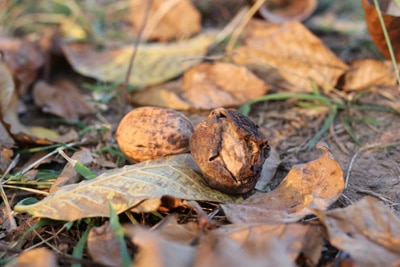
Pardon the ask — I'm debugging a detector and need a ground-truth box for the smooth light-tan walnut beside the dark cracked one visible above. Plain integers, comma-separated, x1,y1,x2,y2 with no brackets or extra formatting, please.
115,107,193,162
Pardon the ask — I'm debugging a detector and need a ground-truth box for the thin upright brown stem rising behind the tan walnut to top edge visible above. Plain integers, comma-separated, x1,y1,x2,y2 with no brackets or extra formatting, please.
121,0,153,114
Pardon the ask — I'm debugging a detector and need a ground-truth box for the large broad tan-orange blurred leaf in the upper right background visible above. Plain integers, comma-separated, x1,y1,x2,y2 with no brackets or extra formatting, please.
233,20,348,92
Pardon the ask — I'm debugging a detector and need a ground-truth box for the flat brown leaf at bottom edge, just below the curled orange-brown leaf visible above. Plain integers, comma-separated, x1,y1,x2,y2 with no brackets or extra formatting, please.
213,223,322,266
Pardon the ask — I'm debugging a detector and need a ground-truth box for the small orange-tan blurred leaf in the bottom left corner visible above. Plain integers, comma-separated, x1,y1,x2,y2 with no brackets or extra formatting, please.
5,248,59,267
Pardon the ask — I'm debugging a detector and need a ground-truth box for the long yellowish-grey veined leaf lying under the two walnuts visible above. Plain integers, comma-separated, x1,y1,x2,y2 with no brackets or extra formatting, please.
15,154,241,221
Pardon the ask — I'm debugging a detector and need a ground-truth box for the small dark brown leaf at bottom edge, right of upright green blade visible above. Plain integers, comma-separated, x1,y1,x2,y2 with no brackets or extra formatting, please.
87,222,123,266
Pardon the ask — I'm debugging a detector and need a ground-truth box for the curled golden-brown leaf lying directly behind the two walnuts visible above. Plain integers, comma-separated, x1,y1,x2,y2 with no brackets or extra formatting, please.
131,62,270,110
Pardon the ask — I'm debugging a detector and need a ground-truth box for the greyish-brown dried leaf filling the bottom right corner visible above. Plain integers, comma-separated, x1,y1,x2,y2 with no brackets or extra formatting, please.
316,197,400,267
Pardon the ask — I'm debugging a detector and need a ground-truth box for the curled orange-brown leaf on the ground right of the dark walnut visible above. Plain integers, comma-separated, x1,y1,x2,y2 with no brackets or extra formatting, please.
221,144,344,223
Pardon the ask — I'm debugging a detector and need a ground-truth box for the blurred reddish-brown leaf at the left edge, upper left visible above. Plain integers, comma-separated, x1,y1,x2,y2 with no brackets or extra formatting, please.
0,36,44,96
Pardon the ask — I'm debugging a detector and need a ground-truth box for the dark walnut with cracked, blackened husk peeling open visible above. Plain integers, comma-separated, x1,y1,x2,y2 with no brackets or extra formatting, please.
190,108,269,194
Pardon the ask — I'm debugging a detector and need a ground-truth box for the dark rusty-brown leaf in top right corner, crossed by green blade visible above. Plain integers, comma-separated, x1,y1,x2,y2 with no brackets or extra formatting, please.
362,0,400,62
